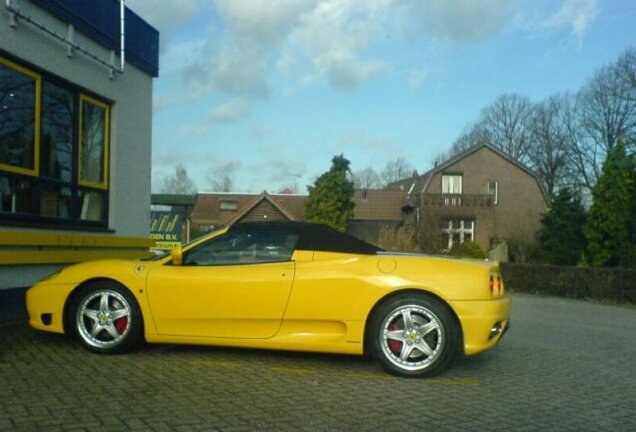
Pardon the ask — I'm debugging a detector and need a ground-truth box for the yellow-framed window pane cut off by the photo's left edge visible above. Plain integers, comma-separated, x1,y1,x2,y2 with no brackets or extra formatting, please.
0,58,40,175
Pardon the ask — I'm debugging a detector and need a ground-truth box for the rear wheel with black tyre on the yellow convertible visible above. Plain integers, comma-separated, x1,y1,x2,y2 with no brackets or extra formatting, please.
369,293,460,377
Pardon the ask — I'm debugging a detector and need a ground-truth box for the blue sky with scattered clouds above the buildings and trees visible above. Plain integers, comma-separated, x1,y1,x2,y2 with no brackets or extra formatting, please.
126,0,636,193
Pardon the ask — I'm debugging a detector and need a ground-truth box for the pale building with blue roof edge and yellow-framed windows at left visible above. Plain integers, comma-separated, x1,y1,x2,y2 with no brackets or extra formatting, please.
0,0,159,318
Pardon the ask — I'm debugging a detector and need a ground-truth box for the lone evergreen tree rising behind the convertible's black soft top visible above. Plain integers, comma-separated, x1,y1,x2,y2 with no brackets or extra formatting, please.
305,155,354,232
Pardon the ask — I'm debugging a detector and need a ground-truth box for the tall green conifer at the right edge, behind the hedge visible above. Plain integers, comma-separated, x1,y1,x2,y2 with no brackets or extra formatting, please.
585,142,636,267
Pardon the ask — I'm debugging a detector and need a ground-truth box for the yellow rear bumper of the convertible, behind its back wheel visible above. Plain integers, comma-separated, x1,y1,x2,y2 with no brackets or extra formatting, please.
449,297,511,355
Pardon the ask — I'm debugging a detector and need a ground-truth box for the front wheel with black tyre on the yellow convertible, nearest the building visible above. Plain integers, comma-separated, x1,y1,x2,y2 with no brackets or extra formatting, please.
67,281,143,354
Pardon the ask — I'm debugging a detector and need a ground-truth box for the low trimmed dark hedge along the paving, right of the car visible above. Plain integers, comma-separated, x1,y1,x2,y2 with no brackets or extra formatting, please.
501,263,636,304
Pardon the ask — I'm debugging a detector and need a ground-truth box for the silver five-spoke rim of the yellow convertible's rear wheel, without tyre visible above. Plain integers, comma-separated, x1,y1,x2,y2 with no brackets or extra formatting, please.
379,304,445,371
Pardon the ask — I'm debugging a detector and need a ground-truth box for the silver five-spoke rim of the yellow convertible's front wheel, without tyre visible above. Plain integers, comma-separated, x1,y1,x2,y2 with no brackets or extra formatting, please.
75,289,132,348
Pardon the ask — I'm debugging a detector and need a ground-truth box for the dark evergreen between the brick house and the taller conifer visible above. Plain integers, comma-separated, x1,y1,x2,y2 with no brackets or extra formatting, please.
538,189,587,265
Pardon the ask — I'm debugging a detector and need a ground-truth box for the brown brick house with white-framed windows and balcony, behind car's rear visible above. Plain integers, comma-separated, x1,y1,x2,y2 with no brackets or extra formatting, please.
387,144,549,251
